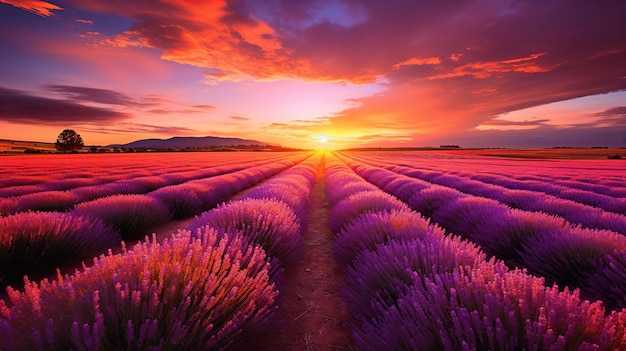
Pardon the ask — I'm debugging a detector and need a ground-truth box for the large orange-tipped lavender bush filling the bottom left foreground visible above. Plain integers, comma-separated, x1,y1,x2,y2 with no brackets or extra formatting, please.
0,228,278,350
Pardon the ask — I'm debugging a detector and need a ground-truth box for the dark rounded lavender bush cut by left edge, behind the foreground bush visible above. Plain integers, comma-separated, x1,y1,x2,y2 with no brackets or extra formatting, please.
0,212,121,285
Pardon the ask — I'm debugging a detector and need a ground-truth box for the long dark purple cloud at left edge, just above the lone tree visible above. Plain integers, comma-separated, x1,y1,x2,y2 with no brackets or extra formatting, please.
0,87,131,125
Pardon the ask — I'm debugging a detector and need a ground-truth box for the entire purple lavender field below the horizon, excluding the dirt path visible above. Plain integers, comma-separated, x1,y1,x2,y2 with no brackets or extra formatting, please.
0,151,626,351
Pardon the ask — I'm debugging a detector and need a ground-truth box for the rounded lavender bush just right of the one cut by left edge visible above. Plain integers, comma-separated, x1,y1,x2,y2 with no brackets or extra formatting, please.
73,195,171,240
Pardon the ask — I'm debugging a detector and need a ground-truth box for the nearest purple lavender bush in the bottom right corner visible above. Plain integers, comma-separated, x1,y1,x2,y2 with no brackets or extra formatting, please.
354,261,626,350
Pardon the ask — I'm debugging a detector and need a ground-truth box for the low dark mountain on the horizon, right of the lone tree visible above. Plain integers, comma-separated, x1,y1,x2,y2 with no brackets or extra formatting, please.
108,136,272,149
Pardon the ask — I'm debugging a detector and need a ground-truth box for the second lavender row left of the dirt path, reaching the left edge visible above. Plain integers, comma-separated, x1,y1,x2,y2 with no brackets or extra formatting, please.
0,157,308,292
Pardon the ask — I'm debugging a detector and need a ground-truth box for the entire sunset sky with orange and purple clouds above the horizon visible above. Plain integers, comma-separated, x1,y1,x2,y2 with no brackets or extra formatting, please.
0,0,626,149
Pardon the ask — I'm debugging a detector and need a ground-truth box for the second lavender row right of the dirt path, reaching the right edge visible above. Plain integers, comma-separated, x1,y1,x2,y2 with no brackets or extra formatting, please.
336,154,626,309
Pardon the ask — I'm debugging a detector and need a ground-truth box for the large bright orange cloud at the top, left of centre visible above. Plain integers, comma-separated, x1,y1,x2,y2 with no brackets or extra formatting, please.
80,1,315,83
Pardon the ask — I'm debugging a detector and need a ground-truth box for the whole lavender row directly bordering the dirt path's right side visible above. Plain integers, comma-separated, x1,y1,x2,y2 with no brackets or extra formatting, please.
327,154,626,350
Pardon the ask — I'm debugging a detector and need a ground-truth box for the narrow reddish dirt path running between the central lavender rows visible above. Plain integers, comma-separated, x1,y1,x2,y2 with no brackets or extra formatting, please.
254,160,356,351
